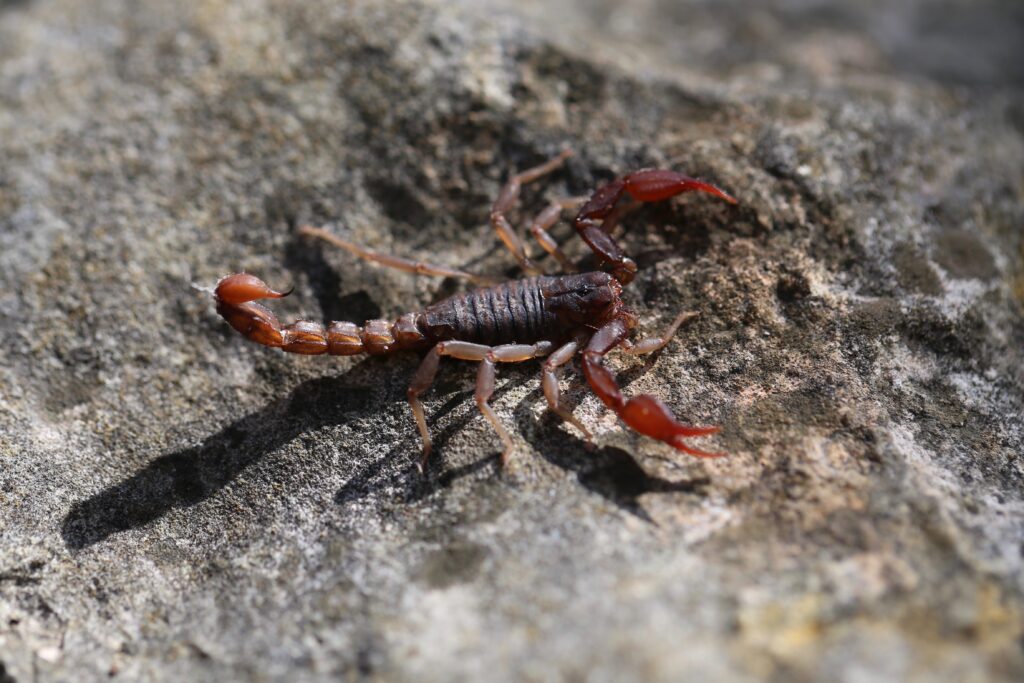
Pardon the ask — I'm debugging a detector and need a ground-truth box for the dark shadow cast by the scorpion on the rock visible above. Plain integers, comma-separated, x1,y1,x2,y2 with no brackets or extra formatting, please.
60,352,707,550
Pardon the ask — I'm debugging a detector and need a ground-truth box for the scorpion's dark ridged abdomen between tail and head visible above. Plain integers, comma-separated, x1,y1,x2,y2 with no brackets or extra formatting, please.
416,276,562,346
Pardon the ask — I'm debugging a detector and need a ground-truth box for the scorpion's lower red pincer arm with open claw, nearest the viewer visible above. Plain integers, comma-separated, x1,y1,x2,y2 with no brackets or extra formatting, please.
583,317,725,458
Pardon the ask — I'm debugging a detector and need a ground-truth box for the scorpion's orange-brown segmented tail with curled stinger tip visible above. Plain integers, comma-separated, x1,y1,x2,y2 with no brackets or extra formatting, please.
214,272,424,355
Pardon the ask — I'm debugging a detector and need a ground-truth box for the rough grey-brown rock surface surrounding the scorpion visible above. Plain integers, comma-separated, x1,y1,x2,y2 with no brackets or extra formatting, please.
0,0,1024,683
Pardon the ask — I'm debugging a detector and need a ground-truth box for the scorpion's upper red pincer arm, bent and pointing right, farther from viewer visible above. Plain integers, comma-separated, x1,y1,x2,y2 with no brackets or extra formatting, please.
572,168,736,285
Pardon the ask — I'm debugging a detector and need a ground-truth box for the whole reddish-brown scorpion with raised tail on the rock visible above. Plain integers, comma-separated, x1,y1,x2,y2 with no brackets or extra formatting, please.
214,151,736,468
